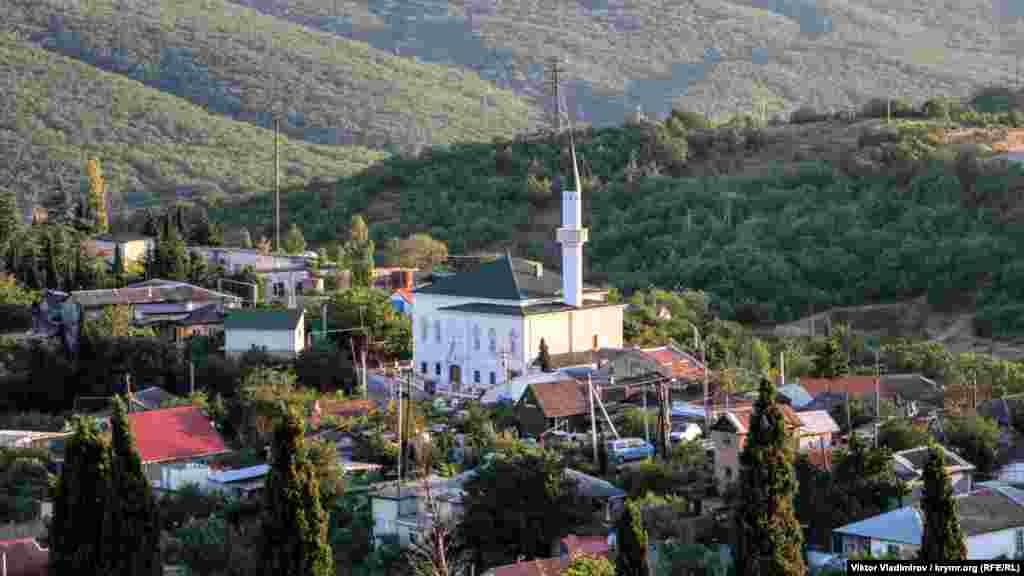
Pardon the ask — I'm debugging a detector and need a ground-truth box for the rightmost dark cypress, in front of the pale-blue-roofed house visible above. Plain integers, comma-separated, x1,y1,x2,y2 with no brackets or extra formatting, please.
918,444,967,562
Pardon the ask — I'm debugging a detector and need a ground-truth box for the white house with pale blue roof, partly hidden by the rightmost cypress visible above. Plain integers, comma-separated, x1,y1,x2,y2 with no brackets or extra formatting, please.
833,483,1024,560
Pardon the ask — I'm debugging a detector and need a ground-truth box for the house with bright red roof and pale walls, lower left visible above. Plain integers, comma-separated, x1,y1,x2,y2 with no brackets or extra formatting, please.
128,406,230,490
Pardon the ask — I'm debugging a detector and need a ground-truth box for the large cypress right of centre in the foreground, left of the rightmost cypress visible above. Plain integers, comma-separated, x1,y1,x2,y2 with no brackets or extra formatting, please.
736,379,807,576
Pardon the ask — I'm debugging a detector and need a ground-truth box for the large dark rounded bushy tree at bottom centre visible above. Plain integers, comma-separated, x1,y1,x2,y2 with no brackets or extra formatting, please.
462,450,578,566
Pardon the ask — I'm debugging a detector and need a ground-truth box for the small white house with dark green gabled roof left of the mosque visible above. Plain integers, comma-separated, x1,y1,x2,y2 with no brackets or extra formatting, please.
224,308,306,359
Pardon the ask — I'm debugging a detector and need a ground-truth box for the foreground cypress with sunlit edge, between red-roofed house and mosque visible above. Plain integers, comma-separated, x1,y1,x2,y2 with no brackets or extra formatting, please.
262,409,334,576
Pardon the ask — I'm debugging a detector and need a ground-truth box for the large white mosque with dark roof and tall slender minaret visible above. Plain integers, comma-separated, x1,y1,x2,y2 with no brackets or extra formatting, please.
413,133,625,389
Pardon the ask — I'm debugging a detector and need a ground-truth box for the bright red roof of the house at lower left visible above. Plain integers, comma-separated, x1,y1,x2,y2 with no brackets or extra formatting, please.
128,406,228,463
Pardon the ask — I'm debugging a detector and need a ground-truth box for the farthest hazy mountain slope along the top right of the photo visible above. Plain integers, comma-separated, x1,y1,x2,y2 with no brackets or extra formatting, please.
230,0,1024,125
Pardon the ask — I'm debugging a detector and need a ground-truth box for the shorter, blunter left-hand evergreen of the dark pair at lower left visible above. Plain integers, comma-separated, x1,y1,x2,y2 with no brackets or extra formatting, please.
49,417,111,576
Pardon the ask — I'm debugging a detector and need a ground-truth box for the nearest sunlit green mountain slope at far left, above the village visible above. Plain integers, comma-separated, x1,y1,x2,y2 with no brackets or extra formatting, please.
0,33,385,208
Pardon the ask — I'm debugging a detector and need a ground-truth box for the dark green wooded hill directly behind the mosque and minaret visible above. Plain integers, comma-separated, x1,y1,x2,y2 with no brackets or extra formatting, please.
207,114,1024,335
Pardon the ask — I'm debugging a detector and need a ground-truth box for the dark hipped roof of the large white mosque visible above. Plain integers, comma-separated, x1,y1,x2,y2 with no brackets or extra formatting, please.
416,256,596,300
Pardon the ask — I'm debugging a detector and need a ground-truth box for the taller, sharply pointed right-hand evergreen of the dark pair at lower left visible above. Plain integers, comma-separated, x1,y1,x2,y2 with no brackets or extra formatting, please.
103,397,163,576
